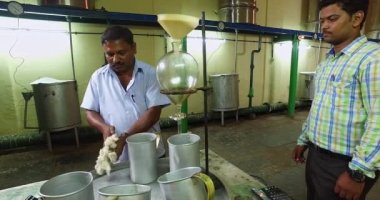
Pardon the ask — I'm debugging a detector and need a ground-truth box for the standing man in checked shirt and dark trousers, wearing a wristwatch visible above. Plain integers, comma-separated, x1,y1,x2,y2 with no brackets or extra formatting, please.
293,0,380,200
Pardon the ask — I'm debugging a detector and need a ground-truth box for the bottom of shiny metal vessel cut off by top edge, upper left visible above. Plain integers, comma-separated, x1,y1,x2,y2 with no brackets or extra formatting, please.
38,0,95,9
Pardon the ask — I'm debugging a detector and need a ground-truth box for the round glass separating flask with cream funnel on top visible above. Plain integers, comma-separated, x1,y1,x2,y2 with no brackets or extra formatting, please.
156,14,199,121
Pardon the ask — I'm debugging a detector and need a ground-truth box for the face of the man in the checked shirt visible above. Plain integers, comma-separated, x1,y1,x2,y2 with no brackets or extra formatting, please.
319,4,356,45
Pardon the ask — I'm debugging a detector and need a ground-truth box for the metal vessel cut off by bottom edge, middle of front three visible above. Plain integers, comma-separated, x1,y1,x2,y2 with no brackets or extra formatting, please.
98,184,151,200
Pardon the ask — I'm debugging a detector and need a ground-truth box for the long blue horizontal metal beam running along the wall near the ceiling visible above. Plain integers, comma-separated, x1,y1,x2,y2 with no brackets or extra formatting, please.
0,1,319,38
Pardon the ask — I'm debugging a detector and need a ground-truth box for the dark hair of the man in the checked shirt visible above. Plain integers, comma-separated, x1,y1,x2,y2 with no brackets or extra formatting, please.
319,0,369,27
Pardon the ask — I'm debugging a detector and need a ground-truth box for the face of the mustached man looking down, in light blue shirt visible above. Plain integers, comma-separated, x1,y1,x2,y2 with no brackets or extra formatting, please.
103,39,136,73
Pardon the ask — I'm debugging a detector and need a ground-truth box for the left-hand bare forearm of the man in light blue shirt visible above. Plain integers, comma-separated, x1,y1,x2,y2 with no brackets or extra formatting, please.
86,110,115,140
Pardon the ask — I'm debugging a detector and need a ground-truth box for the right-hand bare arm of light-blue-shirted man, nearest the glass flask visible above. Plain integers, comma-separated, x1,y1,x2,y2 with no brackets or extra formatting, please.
116,106,161,156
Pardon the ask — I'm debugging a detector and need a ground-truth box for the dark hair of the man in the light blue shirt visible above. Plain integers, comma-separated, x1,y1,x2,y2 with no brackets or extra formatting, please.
101,26,134,45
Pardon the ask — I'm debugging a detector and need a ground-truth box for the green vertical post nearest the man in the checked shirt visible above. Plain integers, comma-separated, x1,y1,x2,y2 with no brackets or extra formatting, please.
288,35,299,117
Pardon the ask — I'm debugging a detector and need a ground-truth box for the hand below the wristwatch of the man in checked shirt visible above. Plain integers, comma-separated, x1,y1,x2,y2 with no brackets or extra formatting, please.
334,171,365,200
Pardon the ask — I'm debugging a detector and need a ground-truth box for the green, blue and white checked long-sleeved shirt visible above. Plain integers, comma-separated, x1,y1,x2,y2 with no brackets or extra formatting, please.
297,36,380,178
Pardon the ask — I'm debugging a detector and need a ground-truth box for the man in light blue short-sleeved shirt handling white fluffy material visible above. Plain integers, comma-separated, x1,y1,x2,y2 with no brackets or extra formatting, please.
81,26,170,161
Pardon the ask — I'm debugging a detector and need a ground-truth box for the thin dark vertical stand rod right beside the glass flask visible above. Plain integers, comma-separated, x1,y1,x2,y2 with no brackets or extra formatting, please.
202,11,208,174
